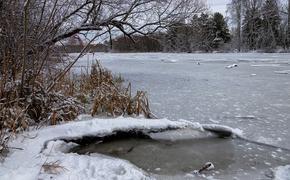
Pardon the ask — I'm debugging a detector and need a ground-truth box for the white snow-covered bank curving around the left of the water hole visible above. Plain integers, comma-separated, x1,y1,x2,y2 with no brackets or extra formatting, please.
0,118,193,180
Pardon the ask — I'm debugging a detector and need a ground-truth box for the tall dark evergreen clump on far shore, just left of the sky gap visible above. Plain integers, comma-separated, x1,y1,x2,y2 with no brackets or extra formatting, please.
162,13,231,52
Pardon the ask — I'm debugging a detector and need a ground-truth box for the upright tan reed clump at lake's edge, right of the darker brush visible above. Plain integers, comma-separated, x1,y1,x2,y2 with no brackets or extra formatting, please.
79,61,152,118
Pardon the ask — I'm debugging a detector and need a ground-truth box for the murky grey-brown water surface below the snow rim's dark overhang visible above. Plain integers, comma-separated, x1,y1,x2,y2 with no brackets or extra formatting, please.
72,131,290,179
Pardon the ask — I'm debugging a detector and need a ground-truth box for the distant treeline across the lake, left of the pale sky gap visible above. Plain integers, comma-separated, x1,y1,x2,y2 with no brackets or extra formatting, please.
105,13,231,52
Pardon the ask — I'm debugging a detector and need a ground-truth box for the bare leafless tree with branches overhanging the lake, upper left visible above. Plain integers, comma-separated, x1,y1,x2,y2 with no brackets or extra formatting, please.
0,0,204,91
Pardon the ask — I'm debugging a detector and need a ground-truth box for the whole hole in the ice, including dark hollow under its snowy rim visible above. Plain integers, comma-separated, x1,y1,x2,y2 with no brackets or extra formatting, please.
70,129,289,177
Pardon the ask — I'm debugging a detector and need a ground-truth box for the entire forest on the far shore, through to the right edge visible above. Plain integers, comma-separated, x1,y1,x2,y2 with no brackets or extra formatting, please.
94,0,290,53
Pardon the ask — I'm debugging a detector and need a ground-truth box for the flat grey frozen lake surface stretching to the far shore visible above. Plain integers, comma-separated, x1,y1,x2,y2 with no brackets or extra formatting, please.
78,53,290,149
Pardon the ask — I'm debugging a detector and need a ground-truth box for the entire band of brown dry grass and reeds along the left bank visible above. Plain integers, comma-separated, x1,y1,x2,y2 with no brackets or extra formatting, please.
0,61,155,158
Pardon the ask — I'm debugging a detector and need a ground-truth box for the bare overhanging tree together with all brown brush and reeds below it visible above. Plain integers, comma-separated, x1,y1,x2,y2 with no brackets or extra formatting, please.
0,0,197,158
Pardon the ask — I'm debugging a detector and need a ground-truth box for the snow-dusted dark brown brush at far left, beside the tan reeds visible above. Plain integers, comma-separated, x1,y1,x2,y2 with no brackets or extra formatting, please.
0,68,84,156
